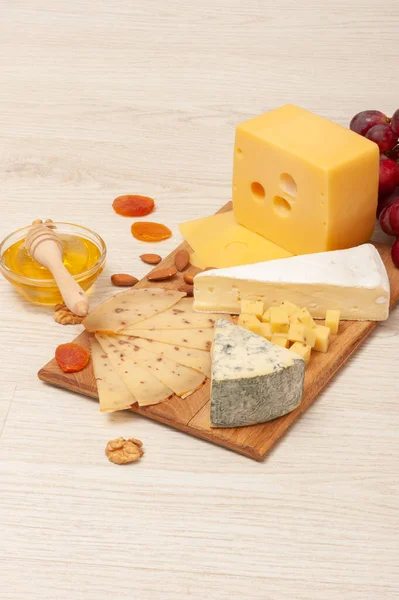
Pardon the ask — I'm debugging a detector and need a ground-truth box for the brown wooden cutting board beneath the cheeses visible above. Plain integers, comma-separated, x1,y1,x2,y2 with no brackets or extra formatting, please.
38,203,399,460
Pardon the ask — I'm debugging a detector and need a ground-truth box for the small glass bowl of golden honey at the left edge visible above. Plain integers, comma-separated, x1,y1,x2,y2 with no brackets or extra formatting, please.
0,222,107,305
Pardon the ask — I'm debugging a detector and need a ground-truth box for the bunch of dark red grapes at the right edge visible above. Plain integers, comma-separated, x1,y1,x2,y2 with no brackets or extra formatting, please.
350,108,399,267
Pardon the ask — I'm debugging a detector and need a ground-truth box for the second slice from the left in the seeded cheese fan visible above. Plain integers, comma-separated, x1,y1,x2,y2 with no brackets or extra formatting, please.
96,334,173,406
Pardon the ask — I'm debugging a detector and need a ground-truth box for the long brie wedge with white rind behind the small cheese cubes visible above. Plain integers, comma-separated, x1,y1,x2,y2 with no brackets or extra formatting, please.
194,244,390,321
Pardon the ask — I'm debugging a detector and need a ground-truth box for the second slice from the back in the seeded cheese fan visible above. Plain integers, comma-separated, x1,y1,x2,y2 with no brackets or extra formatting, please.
120,298,223,335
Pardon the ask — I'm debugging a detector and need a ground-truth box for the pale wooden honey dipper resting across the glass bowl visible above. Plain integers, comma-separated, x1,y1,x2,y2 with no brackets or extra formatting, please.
25,220,89,317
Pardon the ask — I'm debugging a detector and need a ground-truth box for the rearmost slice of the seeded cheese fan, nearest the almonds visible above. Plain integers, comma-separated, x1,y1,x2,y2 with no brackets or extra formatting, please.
83,288,185,333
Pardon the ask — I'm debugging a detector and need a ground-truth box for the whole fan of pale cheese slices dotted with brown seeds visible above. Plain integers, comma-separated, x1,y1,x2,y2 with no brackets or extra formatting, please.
83,288,230,411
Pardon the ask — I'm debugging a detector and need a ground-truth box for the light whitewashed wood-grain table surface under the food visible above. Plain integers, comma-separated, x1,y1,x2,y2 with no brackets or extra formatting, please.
0,0,399,600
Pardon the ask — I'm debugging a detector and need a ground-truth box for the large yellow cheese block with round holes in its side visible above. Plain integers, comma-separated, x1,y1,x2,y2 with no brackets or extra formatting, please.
233,105,379,254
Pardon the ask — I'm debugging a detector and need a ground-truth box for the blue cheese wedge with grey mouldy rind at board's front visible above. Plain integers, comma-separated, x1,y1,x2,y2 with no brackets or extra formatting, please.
211,319,305,427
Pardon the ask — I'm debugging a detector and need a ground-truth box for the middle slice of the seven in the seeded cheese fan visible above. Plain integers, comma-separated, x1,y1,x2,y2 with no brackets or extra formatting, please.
116,335,211,378
